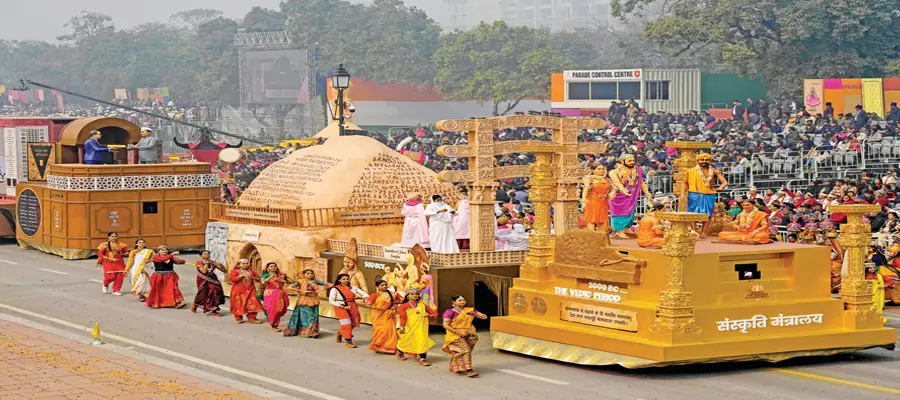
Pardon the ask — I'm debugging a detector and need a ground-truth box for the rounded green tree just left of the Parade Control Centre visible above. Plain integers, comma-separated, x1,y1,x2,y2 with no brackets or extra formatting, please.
434,21,573,116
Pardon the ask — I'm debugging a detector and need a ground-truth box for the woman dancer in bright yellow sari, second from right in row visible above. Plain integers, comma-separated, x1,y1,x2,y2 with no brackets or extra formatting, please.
397,289,437,367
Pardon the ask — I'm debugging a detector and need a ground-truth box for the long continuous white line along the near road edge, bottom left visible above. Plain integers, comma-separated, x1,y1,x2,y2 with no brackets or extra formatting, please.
0,303,344,400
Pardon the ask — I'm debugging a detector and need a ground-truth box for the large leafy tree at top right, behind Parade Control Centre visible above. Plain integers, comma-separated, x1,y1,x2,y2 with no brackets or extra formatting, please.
612,0,900,96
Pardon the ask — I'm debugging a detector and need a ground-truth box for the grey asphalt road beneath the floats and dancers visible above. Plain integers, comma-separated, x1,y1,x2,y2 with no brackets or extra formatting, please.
0,242,900,400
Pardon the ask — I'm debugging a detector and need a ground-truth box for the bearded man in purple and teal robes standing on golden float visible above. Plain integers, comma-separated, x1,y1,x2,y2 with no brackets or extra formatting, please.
609,154,653,239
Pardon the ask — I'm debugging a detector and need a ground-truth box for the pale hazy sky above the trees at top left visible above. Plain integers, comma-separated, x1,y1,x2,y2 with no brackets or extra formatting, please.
0,0,280,41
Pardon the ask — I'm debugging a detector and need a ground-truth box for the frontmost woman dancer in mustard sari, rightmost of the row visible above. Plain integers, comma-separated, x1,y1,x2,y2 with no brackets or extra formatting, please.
441,295,487,378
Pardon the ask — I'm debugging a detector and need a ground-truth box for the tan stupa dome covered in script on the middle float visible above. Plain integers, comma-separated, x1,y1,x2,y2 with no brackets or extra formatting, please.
238,136,459,211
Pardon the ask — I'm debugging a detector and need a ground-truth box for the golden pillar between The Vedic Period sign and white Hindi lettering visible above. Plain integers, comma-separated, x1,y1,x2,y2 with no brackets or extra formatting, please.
650,212,709,343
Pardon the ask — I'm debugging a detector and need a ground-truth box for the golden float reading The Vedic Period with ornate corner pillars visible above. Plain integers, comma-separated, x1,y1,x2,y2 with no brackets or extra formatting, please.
488,138,897,368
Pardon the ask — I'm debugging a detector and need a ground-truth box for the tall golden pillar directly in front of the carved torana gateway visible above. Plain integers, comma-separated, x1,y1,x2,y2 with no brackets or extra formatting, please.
520,146,561,281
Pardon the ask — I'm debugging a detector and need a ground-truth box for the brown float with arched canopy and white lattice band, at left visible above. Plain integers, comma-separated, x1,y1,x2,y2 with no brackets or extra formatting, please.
16,118,218,259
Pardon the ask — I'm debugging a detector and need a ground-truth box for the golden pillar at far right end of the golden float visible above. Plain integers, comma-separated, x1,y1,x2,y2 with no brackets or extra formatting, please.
828,204,884,329
